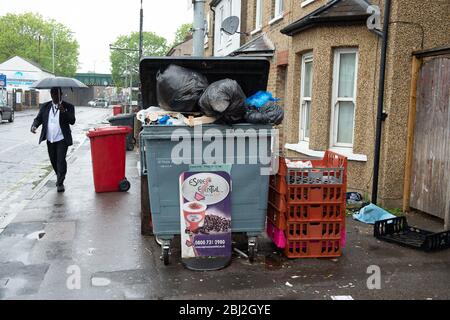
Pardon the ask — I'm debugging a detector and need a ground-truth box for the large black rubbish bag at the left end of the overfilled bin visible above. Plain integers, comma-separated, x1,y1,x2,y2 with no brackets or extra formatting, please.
156,64,208,112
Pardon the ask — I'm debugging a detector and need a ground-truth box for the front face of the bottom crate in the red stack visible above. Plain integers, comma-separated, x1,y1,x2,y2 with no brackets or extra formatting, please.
284,239,342,259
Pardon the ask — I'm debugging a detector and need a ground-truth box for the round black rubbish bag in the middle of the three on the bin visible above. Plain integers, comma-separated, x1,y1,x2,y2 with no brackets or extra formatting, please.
199,79,246,124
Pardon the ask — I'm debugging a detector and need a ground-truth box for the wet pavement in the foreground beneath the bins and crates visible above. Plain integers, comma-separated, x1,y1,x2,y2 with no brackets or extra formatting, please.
0,108,450,300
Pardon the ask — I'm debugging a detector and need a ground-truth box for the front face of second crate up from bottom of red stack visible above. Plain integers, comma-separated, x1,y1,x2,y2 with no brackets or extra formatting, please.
286,221,343,240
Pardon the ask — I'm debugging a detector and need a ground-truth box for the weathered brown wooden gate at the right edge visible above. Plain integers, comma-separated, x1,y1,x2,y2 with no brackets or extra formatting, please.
410,57,450,219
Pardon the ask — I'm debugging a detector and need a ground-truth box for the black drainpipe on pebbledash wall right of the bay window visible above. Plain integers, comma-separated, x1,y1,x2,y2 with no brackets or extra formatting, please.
372,0,391,204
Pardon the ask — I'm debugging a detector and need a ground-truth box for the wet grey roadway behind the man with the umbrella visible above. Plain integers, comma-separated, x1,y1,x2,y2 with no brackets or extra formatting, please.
0,107,112,232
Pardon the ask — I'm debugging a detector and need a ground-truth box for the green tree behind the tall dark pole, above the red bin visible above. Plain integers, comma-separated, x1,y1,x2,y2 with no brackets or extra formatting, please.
110,32,168,87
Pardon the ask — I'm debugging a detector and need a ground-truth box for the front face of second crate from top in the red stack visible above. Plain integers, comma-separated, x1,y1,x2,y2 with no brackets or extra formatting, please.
287,185,346,204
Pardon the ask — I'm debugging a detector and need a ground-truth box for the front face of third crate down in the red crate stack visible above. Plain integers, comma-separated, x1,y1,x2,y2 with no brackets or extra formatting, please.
286,203,345,221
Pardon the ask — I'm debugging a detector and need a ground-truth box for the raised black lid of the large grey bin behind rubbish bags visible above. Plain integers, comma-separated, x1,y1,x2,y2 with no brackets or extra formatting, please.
139,57,270,107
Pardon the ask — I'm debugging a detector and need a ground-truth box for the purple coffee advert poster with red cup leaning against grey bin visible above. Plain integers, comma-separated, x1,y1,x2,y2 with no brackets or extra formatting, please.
180,171,231,258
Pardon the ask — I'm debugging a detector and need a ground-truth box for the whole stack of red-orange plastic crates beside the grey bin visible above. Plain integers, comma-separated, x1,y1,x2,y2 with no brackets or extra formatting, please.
267,151,347,258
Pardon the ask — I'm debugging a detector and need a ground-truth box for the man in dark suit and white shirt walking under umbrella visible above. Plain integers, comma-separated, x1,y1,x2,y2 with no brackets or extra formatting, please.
31,88,75,192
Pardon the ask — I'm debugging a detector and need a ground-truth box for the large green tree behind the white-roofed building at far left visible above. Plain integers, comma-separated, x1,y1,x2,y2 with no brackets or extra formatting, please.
0,13,79,77
